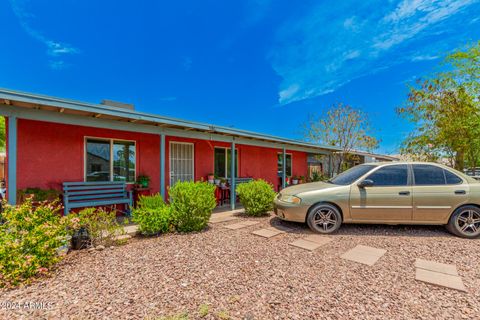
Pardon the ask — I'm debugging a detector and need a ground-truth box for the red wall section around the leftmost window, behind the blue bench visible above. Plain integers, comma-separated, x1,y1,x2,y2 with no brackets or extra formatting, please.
17,119,160,192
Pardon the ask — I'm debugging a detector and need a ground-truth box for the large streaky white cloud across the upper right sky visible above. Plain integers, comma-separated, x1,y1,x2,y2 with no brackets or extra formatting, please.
268,0,480,104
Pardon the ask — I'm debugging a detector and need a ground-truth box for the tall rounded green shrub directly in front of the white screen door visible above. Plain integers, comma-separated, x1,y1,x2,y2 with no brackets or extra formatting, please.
169,182,217,232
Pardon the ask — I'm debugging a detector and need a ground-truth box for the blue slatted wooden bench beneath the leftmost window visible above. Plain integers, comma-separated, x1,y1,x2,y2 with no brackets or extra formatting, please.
63,182,133,215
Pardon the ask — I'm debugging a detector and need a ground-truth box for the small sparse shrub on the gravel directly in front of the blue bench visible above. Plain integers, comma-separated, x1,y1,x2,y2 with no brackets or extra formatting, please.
65,208,125,246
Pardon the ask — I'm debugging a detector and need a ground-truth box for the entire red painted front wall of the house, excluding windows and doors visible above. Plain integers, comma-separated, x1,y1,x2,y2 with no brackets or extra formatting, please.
12,119,307,196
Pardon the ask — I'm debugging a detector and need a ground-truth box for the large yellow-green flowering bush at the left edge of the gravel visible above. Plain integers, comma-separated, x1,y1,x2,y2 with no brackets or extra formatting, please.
0,199,68,287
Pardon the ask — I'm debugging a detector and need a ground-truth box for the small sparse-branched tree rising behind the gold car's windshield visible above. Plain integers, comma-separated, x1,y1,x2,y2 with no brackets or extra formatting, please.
304,103,379,173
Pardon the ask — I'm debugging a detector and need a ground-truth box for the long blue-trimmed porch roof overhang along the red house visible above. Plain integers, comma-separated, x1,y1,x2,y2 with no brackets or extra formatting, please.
0,89,341,154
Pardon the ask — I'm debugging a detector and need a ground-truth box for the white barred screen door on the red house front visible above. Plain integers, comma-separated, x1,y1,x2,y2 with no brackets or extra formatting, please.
170,142,194,186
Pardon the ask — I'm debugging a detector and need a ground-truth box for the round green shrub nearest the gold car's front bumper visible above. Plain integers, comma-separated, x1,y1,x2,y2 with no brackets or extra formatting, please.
236,179,275,216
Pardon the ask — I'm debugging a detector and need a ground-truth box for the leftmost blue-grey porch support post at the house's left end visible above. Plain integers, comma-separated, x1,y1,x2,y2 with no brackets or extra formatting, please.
7,116,17,205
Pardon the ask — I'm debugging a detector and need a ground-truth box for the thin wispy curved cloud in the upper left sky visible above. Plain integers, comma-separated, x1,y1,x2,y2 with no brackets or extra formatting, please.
10,0,79,70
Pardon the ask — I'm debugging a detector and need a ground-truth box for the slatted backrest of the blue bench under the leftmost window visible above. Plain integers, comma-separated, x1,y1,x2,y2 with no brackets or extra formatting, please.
63,181,128,202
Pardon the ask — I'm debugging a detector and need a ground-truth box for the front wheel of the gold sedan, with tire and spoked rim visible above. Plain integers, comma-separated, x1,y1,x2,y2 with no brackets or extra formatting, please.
307,203,342,234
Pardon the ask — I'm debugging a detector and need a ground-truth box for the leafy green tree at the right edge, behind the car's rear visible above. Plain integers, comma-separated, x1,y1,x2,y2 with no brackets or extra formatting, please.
397,42,480,170
